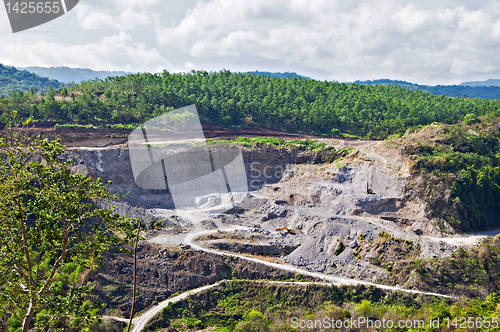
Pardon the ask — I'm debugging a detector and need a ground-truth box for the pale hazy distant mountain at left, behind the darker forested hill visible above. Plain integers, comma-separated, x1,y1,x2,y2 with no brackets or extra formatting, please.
19,67,130,83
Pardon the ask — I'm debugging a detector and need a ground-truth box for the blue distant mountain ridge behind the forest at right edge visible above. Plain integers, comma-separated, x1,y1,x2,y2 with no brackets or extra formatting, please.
353,79,500,99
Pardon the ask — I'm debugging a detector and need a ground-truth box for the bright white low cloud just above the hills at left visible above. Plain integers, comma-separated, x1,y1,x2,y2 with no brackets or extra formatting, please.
0,32,170,71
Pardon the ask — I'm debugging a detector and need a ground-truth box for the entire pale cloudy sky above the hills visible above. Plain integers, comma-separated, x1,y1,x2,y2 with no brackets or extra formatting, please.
0,0,500,85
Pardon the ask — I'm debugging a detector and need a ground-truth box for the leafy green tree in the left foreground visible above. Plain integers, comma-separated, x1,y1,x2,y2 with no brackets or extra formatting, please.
0,118,133,332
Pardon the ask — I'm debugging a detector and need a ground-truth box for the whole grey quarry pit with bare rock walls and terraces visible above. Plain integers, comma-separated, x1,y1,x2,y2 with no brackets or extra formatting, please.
64,139,480,287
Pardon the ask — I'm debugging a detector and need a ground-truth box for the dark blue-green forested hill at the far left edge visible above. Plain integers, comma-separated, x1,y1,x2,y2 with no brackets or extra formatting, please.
0,64,66,96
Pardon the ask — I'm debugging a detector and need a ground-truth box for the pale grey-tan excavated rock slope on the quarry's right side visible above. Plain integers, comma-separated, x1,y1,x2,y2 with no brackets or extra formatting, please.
194,146,456,281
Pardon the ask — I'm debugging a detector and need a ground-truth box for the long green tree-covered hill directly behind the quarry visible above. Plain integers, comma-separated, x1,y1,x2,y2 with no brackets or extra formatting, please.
0,71,500,138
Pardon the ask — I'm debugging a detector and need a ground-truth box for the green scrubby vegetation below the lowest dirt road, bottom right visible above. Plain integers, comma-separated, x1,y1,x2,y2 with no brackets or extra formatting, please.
145,281,500,332
